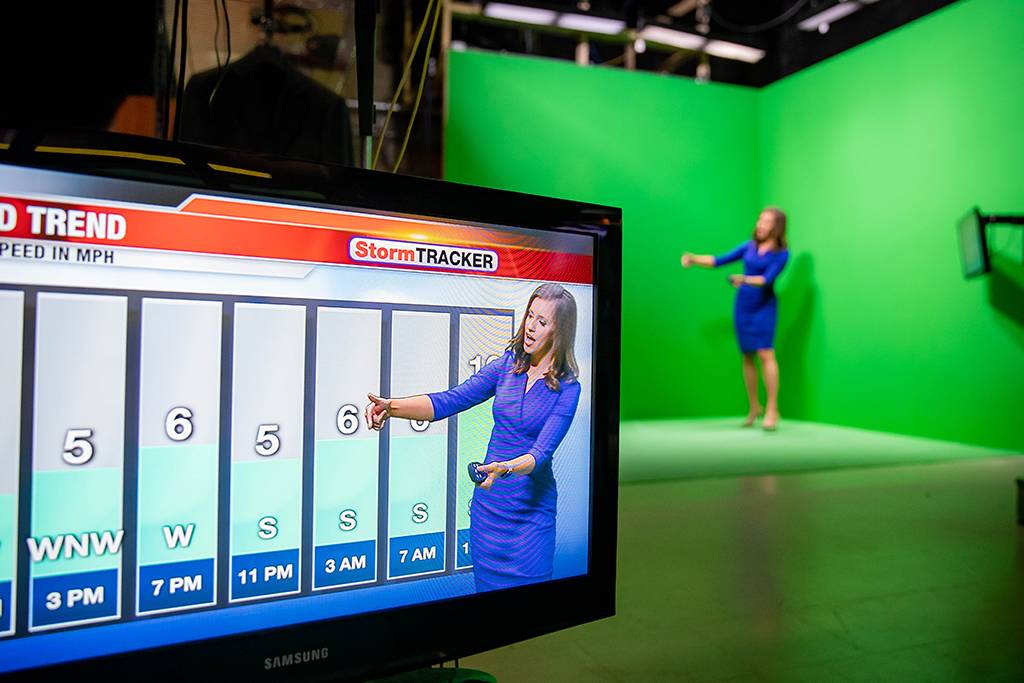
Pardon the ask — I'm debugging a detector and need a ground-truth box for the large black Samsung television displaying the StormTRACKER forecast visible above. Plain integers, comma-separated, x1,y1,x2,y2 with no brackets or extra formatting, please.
0,131,622,680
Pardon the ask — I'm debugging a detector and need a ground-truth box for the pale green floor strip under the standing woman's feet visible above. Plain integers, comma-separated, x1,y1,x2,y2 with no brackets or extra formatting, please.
618,418,1019,483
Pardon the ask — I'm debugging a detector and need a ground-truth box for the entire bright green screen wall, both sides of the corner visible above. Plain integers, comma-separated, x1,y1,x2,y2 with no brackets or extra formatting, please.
445,0,1024,449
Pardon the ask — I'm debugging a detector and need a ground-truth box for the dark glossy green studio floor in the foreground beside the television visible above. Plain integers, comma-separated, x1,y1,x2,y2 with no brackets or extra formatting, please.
461,458,1024,683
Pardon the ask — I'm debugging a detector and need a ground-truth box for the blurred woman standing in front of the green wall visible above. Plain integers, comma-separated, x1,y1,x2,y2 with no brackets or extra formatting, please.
682,207,790,431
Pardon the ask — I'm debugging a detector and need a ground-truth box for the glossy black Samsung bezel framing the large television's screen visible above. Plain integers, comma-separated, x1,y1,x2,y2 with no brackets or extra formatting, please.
0,130,622,680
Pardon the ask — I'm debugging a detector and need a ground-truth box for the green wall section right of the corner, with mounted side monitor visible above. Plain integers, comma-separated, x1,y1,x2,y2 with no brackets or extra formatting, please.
760,0,1024,449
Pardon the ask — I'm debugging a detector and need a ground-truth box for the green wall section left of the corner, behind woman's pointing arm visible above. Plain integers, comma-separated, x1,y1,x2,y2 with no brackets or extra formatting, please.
444,52,760,420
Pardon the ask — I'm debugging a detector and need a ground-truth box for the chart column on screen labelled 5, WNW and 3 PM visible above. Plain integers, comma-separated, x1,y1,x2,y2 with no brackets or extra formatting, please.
26,292,128,631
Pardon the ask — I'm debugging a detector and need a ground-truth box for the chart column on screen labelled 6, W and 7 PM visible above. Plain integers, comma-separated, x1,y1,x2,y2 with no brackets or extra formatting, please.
136,299,221,614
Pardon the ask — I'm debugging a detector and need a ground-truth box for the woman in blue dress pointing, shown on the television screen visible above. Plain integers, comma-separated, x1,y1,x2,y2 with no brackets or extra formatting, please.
366,285,580,591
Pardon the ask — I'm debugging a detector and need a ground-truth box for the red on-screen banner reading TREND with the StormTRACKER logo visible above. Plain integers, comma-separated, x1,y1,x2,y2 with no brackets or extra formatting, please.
0,197,593,284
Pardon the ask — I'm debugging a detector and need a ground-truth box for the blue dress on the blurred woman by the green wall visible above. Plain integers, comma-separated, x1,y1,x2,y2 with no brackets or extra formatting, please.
715,240,790,353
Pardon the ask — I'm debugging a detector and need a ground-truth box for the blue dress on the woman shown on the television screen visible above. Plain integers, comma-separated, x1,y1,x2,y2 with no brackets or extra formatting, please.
427,351,580,591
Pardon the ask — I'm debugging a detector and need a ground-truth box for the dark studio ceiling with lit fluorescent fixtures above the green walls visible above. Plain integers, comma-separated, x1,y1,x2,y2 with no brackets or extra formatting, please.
453,0,952,87
